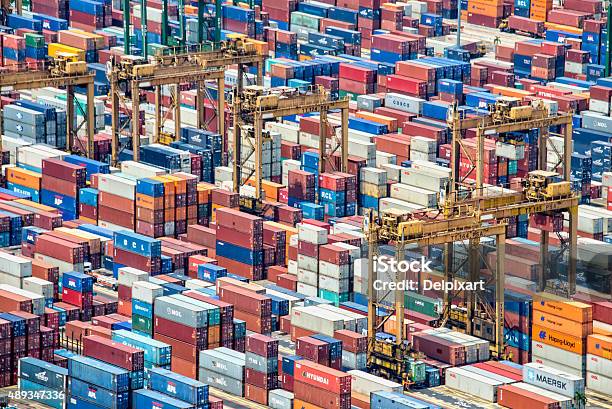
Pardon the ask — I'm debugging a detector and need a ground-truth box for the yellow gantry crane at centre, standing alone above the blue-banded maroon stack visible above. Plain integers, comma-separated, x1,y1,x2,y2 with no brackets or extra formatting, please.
232,84,349,208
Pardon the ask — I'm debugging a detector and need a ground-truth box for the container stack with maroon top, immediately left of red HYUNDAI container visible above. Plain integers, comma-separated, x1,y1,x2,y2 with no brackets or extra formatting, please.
244,334,278,405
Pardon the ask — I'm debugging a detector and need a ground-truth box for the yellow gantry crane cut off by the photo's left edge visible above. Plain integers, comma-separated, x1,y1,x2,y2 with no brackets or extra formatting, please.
0,54,95,158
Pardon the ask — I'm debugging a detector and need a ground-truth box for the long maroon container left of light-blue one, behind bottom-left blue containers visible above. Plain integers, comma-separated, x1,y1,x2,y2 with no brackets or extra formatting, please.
83,335,144,371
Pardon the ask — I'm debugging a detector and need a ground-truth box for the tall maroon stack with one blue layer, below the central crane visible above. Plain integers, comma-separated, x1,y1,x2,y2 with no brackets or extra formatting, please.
216,208,264,280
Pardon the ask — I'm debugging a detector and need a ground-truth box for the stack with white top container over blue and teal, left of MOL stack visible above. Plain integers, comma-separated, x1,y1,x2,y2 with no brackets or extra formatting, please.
131,281,164,338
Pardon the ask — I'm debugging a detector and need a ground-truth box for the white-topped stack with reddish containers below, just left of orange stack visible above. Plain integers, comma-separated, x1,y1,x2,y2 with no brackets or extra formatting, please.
93,174,136,230
